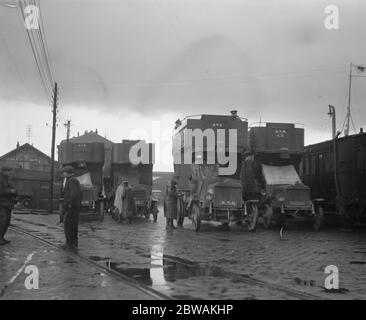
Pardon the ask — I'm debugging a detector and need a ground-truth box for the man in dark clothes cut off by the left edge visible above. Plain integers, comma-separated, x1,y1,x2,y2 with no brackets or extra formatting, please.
0,167,16,245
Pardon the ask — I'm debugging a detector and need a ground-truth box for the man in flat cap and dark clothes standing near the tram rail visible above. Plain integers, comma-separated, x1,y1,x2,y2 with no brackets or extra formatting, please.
61,166,82,249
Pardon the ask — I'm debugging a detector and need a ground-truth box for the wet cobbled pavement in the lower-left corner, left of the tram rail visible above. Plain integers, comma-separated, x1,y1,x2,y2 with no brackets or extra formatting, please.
0,230,156,300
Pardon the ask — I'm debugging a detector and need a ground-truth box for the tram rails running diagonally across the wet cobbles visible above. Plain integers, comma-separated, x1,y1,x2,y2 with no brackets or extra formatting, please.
10,219,326,300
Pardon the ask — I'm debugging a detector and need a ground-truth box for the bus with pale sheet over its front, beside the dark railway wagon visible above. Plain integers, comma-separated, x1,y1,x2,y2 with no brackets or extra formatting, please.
242,123,323,230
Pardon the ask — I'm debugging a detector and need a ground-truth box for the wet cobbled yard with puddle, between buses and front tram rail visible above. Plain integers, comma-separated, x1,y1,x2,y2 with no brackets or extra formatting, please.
4,208,366,299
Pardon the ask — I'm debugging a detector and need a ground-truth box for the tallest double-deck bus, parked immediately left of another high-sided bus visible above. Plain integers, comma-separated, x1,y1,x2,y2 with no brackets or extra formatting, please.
173,111,258,231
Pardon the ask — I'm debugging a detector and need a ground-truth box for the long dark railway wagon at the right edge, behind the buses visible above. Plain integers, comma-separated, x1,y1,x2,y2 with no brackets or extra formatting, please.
301,131,366,226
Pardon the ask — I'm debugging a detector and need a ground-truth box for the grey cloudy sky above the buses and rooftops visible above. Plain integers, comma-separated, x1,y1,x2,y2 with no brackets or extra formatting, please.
0,0,366,170
